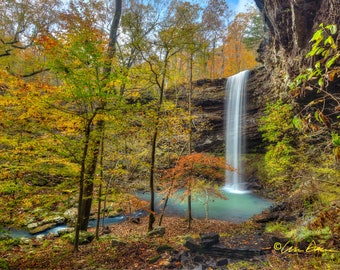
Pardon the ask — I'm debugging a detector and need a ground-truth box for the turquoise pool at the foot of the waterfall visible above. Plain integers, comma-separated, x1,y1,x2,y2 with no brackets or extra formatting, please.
137,190,272,222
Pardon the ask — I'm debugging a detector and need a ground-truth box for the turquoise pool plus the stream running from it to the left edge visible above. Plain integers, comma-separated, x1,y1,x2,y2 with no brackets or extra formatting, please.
0,190,272,238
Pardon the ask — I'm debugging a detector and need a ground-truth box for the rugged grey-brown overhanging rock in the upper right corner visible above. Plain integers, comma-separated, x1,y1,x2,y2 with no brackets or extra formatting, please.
255,0,340,83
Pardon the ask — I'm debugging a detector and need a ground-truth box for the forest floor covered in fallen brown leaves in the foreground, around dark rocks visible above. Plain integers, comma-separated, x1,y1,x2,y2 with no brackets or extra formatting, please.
0,214,339,269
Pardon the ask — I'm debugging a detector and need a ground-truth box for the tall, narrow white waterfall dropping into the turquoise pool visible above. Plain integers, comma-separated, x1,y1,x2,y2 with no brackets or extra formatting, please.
224,70,249,193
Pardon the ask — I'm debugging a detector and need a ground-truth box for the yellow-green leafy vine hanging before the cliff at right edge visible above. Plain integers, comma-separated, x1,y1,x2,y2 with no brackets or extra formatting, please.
290,24,340,160
